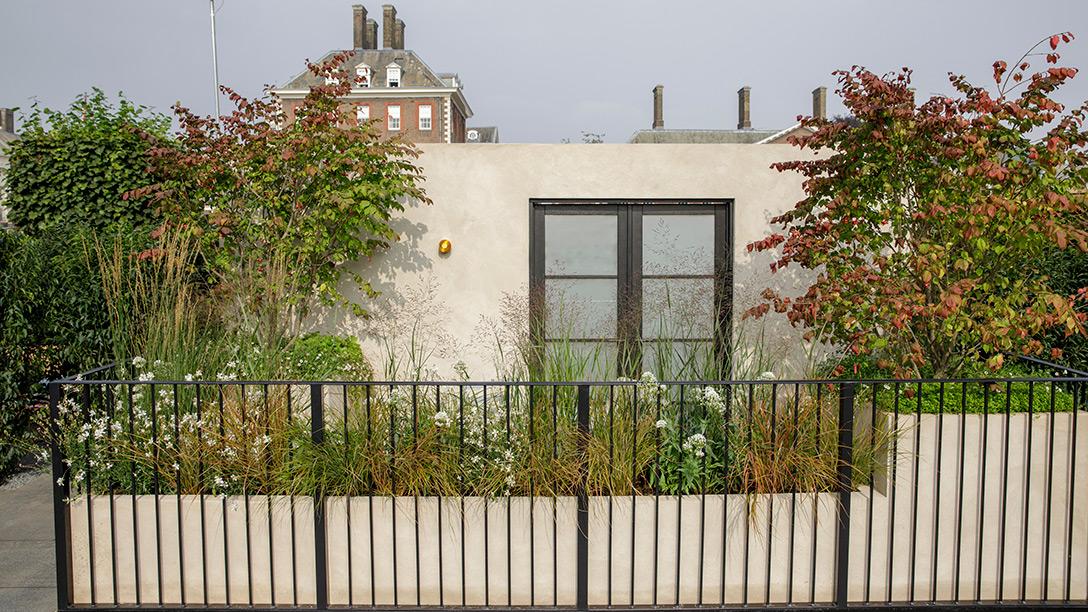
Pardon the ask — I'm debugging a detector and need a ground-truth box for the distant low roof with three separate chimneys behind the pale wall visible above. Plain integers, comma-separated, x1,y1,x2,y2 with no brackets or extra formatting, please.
628,85,827,145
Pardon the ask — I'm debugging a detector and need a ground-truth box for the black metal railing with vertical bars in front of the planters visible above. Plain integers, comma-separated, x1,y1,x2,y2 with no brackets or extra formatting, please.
48,366,1088,610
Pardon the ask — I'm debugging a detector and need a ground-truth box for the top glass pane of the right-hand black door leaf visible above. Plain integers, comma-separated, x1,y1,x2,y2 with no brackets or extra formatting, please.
642,215,714,274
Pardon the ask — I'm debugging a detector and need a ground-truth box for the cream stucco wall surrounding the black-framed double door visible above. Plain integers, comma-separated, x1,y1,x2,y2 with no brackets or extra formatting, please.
321,145,811,379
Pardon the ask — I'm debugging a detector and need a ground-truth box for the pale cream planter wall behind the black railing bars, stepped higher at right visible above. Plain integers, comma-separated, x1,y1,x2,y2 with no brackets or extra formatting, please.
70,413,1088,605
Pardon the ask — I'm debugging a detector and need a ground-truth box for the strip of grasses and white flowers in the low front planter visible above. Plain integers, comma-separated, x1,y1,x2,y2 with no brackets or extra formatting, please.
53,362,900,495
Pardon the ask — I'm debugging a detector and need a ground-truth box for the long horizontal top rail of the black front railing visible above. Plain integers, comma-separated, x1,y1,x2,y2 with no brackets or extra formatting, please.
45,374,1088,387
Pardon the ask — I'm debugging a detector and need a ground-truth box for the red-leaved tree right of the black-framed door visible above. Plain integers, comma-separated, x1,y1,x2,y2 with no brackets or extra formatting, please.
747,33,1088,377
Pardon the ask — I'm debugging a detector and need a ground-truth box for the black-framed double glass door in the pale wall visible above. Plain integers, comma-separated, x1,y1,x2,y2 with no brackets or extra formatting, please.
530,200,732,379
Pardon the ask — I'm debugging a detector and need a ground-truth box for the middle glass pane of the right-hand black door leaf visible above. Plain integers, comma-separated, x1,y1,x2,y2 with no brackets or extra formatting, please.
642,279,716,339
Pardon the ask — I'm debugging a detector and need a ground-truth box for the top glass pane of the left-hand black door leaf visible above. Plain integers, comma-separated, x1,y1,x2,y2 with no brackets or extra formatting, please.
544,215,617,274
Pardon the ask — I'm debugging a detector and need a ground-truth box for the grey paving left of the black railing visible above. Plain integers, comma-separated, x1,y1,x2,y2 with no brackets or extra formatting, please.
0,470,57,612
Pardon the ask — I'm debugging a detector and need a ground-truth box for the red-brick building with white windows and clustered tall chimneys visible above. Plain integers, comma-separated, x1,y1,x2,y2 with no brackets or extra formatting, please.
272,4,485,143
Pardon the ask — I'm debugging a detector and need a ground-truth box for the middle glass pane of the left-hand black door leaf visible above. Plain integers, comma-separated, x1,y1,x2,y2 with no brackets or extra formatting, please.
544,279,616,339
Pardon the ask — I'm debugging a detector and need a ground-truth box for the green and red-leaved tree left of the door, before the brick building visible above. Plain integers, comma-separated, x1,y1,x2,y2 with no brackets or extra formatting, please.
138,52,430,335
